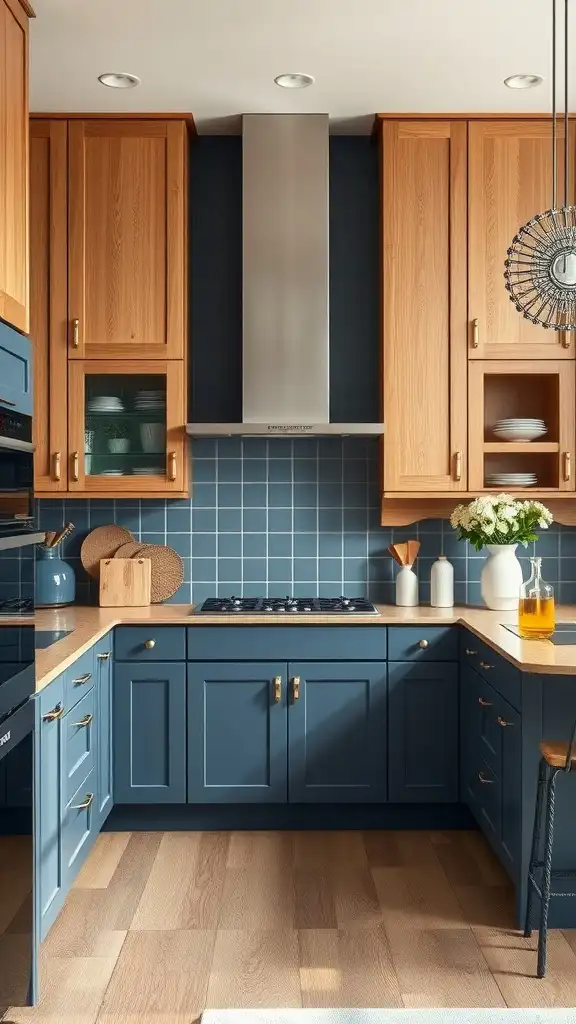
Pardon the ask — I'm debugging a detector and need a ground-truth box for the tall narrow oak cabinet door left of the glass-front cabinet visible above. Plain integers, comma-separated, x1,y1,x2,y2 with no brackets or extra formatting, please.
30,120,68,495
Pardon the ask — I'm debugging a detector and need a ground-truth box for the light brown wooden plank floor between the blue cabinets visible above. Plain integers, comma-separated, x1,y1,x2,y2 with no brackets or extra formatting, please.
5,831,576,1024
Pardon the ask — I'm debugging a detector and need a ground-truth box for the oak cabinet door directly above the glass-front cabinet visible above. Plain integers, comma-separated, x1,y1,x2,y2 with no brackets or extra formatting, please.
69,119,188,359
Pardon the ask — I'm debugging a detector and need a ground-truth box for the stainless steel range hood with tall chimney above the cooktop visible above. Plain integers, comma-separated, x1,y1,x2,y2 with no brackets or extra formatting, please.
187,114,384,436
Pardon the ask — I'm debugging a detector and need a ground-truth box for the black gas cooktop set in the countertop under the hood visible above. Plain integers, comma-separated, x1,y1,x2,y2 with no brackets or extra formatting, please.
196,596,379,615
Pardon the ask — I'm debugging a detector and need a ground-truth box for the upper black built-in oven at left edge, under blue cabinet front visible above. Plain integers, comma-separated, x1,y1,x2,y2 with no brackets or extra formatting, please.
0,406,34,538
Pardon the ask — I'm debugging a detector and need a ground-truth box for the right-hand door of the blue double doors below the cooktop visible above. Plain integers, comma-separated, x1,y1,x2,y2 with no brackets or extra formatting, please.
288,662,386,804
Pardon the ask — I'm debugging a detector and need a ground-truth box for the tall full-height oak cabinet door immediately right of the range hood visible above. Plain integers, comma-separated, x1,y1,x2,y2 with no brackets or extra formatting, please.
382,121,467,493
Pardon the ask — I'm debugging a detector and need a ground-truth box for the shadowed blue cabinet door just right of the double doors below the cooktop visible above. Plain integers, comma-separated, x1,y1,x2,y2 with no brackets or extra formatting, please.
388,662,459,803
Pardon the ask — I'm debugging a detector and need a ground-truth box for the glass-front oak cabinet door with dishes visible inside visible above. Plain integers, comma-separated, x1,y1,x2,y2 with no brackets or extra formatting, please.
69,360,187,496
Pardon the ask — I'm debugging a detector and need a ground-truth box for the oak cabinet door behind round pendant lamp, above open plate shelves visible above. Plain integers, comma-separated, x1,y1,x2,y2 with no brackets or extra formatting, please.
468,120,576,360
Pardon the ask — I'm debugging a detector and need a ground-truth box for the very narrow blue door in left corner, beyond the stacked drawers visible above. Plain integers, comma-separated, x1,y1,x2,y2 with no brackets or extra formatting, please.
94,633,113,830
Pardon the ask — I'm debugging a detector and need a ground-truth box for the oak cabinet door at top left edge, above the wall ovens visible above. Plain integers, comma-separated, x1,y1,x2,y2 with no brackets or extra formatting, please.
0,0,31,333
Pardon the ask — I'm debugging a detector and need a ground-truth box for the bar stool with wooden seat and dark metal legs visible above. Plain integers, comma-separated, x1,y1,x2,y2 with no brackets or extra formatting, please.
524,721,576,978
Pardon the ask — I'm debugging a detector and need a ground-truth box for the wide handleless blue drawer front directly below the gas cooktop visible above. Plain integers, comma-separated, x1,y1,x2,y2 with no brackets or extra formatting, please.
186,625,386,662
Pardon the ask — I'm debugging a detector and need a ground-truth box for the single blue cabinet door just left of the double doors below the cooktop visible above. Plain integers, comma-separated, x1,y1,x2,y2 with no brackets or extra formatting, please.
113,662,187,804
